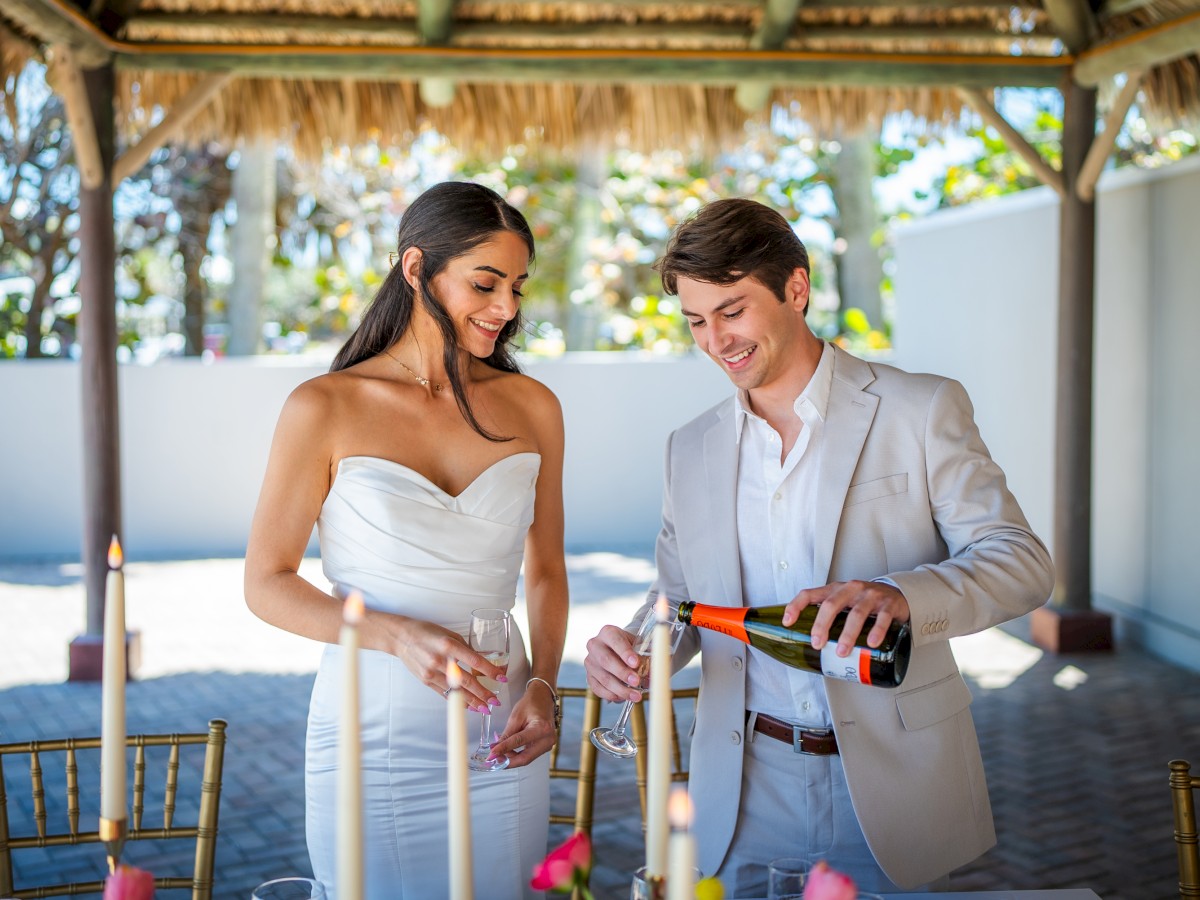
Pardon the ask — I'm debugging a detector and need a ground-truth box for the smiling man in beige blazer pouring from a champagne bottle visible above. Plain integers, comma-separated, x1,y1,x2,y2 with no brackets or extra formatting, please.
586,199,1054,896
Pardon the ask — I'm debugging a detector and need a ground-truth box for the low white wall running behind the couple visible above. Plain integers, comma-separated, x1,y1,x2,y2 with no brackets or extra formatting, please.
0,353,732,559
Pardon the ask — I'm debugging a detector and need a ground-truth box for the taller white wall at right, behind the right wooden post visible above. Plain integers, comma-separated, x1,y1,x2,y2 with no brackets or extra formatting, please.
895,158,1200,670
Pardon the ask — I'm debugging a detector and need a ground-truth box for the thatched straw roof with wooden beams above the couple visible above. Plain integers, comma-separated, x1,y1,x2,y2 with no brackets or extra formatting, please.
0,0,1200,152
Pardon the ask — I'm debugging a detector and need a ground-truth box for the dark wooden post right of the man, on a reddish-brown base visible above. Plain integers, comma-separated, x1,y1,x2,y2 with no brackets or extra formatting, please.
1031,79,1112,652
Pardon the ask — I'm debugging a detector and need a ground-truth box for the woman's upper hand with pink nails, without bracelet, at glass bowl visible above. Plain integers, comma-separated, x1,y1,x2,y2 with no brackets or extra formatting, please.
381,611,508,713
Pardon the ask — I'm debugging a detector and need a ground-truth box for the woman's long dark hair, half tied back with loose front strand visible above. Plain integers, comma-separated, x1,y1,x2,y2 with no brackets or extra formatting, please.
329,181,534,440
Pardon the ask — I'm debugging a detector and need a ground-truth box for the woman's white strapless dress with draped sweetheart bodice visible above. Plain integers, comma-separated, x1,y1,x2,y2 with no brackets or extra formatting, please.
305,452,550,900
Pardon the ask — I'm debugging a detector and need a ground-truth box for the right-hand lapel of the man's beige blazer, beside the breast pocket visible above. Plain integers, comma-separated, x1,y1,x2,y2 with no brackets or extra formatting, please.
812,347,880,584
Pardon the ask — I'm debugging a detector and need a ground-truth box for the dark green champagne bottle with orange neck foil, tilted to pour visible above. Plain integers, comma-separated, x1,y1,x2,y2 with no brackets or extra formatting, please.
678,600,912,688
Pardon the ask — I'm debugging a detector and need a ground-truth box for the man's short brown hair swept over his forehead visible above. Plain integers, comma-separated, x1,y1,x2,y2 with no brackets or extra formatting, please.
654,198,809,302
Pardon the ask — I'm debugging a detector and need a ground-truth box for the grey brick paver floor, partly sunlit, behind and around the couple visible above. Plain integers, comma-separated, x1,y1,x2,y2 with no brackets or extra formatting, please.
0,551,1200,900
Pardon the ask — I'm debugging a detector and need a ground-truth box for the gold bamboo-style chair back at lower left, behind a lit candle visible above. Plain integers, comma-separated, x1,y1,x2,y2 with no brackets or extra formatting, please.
0,719,226,900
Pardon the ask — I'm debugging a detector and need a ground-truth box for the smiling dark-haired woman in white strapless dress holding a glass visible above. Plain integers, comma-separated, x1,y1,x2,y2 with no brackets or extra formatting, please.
246,182,566,900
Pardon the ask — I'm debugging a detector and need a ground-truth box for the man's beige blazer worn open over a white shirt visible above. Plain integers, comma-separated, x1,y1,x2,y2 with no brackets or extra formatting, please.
640,350,1054,887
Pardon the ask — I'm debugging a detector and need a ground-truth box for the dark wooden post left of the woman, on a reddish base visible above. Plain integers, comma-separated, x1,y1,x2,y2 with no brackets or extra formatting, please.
67,64,134,680
